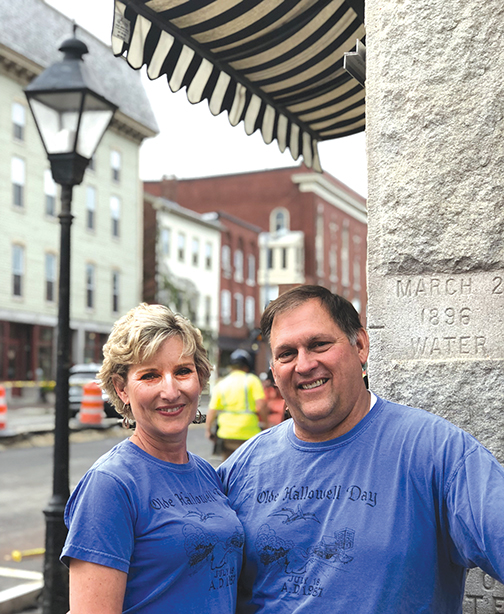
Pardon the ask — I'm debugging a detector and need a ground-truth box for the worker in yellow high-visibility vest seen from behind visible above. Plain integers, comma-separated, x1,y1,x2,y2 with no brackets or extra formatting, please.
206,350,267,460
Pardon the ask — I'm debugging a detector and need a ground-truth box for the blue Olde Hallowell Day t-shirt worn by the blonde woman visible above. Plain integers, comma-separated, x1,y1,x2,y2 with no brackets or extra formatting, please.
62,440,244,614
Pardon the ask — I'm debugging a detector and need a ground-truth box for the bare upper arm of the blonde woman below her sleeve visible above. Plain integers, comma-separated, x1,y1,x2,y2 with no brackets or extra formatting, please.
70,559,128,614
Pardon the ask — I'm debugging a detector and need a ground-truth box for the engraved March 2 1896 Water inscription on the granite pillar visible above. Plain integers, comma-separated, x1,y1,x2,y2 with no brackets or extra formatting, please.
385,272,504,361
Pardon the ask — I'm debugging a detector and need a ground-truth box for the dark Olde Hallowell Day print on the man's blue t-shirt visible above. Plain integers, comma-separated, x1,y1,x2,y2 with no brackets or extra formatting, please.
249,482,379,598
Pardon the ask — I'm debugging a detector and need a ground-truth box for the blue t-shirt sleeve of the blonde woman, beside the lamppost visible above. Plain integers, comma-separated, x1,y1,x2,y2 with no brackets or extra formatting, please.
61,471,135,573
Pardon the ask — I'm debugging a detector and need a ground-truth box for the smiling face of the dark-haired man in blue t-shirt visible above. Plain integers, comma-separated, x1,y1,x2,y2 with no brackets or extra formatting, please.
270,299,370,441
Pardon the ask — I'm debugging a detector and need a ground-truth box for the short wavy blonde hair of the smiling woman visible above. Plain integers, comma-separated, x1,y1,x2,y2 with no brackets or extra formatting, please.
98,303,212,420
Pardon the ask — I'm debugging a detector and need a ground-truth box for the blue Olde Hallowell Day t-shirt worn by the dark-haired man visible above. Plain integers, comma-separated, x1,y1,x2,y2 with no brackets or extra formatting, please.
218,399,504,614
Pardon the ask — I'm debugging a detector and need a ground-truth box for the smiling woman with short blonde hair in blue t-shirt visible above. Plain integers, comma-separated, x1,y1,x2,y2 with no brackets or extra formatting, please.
62,304,243,614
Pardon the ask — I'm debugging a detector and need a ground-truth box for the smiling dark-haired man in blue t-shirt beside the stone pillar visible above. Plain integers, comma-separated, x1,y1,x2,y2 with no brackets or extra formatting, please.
219,286,504,614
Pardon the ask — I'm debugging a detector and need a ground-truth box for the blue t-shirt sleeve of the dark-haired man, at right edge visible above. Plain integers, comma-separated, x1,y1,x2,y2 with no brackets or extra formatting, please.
446,446,504,582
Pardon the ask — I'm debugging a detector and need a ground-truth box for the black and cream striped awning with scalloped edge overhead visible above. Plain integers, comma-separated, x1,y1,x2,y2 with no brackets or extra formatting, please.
112,0,365,170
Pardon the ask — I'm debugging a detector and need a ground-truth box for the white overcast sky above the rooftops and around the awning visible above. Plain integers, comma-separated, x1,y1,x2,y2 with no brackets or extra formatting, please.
45,0,367,197
